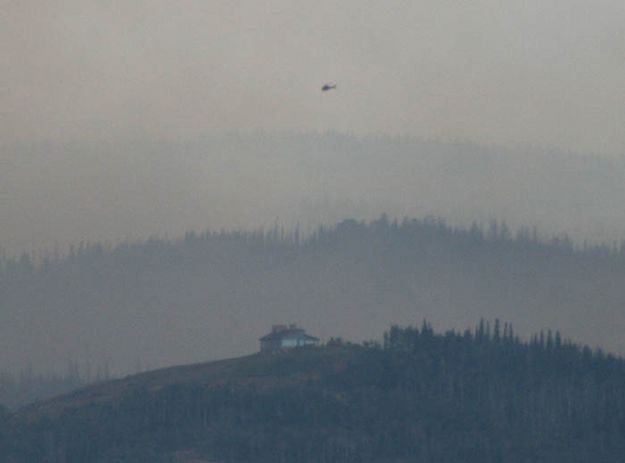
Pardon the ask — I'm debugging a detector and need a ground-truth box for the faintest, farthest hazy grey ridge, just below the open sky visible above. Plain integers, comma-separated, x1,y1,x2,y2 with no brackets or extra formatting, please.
0,132,625,255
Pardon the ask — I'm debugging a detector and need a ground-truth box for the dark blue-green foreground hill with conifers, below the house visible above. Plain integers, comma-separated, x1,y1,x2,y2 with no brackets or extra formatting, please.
0,321,625,463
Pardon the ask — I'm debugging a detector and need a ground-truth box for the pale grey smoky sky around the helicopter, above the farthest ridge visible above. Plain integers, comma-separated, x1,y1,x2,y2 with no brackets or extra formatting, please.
0,0,625,154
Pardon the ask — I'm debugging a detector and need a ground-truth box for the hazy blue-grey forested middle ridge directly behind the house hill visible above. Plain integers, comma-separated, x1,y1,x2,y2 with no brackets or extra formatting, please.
0,216,625,376
